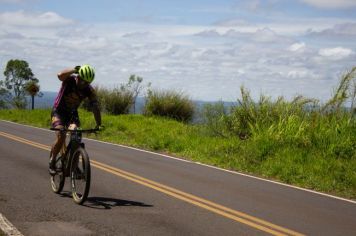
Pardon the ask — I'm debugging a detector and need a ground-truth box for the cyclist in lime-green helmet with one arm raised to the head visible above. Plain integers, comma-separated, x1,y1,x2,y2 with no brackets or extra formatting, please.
49,65,101,175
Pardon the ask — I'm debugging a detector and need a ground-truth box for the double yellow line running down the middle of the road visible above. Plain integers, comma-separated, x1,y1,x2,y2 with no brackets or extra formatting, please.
0,131,303,236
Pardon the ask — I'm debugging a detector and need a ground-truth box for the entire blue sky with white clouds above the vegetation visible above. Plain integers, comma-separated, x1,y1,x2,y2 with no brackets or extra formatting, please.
0,0,356,101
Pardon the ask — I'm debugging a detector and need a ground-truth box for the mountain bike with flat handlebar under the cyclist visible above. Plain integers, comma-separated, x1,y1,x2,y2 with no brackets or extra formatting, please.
50,128,99,204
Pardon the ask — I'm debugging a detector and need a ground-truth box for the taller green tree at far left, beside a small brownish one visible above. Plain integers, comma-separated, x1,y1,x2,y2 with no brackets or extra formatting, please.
3,59,38,108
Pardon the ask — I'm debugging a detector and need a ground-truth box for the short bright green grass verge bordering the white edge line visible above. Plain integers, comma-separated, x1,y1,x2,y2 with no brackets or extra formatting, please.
0,110,356,199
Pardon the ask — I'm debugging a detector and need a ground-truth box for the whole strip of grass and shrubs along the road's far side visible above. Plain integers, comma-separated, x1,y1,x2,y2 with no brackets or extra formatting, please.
0,63,356,199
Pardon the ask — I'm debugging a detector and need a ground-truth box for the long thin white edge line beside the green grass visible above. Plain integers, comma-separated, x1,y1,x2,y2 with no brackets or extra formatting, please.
0,119,356,204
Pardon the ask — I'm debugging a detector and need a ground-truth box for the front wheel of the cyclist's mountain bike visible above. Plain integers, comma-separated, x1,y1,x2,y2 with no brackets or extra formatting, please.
70,147,90,204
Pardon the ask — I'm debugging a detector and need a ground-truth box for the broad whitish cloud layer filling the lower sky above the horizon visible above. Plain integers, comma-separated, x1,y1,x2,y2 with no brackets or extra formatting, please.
0,12,355,100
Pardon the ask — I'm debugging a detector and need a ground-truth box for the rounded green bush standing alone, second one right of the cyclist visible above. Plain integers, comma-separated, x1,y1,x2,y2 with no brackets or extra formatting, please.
144,88,194,122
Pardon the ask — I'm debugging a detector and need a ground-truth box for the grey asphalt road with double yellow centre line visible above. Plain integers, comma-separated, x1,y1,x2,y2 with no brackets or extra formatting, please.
0,121,356,236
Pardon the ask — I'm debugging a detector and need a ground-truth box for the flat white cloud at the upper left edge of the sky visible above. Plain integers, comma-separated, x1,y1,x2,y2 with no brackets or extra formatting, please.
0,11,73,27
